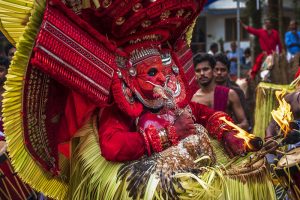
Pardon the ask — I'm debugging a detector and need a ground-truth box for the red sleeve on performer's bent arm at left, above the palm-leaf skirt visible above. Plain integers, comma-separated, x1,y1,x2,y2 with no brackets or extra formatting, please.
99,105,146,162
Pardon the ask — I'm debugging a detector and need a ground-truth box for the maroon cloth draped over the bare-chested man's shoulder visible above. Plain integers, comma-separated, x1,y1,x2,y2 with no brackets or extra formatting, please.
214,85,230,112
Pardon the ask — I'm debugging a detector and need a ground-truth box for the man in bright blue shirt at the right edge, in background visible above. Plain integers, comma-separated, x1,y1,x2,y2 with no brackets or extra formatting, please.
285,20,300,60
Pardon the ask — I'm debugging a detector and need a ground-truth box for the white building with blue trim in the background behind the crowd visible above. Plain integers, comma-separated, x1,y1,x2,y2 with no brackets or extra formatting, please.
192,0,300,51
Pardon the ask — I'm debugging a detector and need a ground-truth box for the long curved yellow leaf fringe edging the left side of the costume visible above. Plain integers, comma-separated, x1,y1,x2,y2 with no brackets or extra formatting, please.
0,0,68,199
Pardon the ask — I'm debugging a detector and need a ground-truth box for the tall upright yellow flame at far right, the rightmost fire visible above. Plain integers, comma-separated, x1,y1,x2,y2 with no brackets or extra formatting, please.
271,90,293,137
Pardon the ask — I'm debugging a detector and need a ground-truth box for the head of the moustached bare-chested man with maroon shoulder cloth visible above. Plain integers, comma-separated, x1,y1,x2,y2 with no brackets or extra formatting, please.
193,54,216,87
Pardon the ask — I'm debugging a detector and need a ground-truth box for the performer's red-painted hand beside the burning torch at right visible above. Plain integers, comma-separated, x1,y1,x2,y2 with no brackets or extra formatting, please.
223,132,246,158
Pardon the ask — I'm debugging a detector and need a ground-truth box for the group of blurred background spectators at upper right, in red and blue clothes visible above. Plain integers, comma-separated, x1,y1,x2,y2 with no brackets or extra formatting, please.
208,19,300,81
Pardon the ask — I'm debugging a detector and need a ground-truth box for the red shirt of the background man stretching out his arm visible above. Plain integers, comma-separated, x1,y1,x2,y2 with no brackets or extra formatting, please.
246,26,282,54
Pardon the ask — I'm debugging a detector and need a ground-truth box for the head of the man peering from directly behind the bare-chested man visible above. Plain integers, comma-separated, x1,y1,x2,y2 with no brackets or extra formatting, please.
214,53,230,85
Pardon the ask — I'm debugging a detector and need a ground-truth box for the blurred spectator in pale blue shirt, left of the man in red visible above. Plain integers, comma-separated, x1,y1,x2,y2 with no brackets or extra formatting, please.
227,41,243,80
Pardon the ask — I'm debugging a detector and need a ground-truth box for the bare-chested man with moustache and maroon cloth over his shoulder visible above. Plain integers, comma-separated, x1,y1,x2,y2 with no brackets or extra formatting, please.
192,54,248,130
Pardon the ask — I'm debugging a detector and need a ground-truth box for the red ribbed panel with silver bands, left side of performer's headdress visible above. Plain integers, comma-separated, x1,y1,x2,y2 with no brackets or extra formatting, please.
30,4,117,106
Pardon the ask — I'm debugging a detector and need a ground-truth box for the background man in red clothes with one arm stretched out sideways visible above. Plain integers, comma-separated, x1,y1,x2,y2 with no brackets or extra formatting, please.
241,19,282,79
